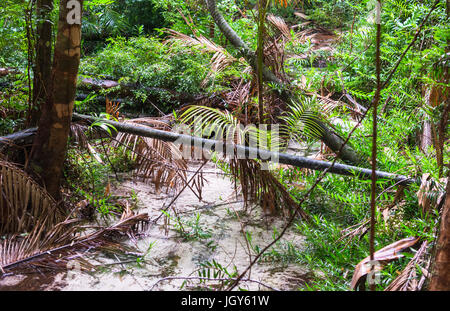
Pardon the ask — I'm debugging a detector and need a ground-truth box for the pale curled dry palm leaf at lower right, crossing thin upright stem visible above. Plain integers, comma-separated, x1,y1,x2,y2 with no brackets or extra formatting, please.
350,237,420,289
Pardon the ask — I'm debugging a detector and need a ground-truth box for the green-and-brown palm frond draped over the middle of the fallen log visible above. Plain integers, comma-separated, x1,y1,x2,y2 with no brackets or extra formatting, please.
180,106,307,218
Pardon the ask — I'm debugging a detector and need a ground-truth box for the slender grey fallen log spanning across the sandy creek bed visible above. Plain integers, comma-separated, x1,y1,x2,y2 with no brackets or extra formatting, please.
72,113,417,184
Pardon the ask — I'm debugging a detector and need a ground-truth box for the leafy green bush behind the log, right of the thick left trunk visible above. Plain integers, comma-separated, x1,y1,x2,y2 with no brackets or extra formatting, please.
80,36,214,111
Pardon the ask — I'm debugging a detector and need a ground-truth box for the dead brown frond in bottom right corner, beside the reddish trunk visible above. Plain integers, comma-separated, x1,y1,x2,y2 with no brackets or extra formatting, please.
384,241,430,291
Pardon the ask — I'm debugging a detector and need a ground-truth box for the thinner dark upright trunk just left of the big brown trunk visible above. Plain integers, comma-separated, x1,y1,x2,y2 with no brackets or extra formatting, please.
29,0,53,125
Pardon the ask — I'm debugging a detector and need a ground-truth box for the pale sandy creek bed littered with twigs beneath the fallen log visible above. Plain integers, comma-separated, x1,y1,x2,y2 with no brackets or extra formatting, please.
0,164,309,291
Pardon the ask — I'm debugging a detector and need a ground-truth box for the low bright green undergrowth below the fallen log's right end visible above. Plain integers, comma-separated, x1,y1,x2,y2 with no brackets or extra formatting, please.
288,169,438,290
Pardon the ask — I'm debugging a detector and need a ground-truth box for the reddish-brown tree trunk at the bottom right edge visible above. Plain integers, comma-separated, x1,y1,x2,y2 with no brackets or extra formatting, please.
430,178,450,291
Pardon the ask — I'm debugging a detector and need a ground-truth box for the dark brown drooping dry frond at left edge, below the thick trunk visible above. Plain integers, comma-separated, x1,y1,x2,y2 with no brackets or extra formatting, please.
0,161,65,234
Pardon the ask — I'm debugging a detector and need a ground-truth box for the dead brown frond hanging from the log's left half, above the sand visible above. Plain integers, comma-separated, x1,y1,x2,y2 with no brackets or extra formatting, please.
114,118,187,191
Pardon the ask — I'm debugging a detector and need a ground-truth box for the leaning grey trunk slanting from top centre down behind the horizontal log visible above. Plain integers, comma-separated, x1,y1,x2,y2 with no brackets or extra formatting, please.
206,0,362,164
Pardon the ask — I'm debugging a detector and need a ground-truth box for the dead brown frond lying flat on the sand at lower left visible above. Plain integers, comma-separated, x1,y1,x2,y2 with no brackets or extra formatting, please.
0,209,148,275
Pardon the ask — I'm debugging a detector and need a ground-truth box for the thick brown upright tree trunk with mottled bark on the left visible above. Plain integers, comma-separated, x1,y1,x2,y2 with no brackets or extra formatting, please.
31,0,83,200
